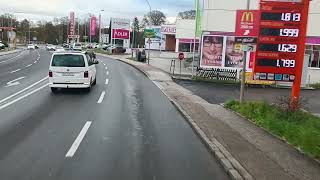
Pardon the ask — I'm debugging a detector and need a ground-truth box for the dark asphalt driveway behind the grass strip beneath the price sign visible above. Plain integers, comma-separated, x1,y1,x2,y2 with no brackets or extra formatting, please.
176,80,320,115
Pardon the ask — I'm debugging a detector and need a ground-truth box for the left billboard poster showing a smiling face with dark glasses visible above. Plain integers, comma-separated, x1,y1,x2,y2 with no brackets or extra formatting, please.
200,36,223,68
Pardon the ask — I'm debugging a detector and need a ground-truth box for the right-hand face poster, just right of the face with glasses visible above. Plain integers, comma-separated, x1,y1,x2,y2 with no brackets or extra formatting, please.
225,37,245,68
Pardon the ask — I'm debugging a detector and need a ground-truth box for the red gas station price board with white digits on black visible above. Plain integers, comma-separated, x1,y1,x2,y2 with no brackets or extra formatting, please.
253,0,307,81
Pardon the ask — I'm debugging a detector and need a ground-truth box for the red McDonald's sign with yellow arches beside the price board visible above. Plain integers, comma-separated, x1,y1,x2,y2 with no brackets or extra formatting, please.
236,10,260,37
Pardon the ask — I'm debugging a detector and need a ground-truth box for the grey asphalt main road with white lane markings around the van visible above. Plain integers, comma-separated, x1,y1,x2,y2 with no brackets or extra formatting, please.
0,49,228,180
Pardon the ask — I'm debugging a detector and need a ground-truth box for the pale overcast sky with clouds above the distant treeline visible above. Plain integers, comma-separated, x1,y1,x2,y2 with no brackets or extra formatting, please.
0,0,194,24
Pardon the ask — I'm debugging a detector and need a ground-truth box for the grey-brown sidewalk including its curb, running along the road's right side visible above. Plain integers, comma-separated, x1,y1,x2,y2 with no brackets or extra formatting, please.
99,53,320,180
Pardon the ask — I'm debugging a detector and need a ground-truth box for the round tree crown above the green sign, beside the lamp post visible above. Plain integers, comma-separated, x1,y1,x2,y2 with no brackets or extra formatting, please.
142,10,166,26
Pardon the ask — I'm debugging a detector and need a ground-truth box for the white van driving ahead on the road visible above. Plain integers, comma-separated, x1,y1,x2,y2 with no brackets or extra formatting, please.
49,52,98,93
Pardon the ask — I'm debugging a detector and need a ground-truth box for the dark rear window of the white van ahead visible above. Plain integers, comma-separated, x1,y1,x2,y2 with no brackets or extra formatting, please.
52,54,86,67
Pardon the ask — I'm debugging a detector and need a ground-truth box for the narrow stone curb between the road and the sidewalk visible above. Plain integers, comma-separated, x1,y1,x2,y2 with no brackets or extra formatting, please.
99,54,254,180
